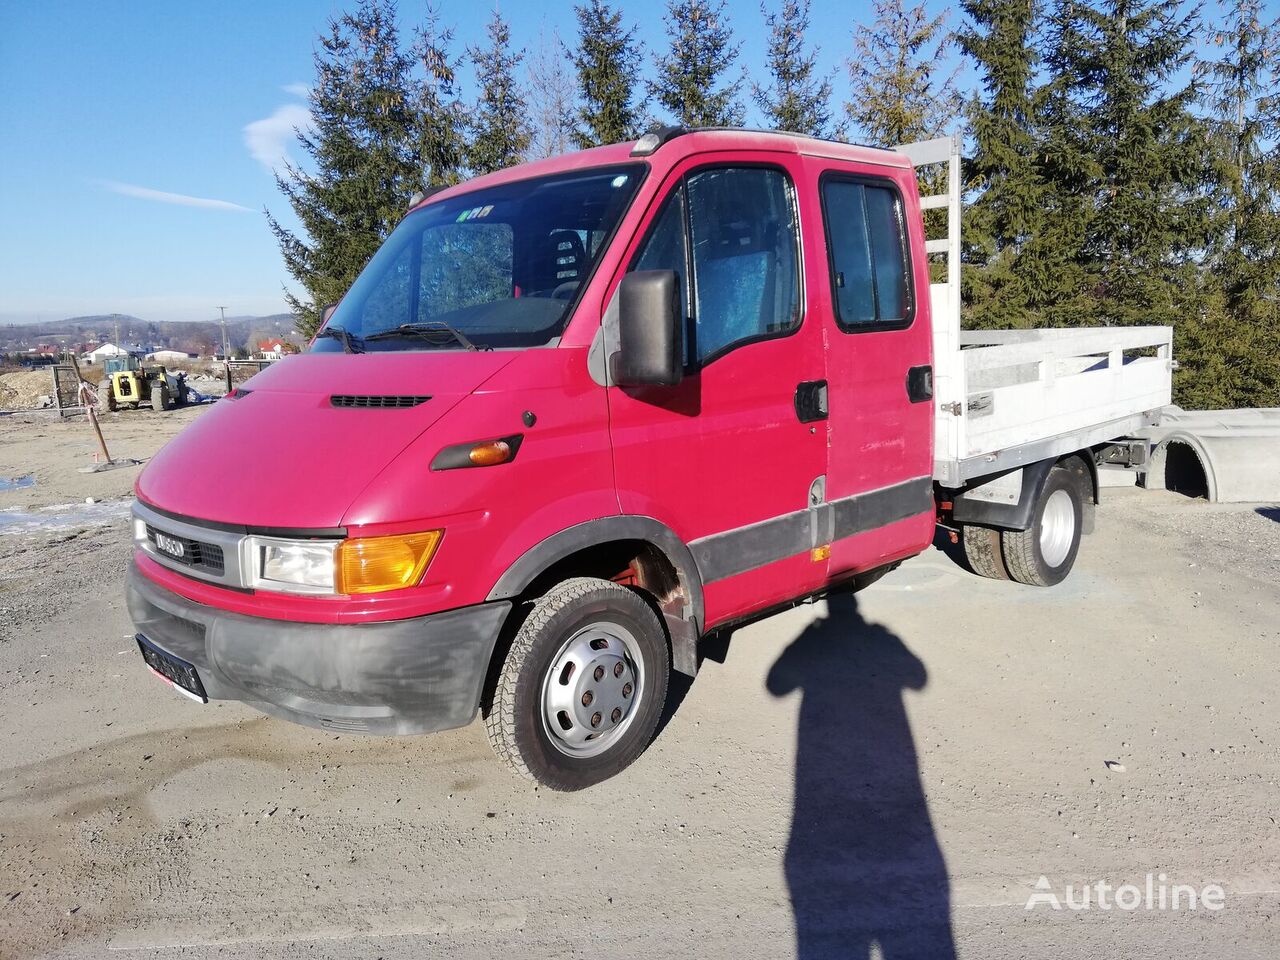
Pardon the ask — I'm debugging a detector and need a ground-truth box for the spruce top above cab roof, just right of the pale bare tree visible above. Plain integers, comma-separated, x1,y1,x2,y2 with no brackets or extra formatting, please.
573,0,643,148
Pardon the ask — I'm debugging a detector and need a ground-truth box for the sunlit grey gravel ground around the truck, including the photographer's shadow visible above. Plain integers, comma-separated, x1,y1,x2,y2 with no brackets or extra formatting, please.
0,411,1280,960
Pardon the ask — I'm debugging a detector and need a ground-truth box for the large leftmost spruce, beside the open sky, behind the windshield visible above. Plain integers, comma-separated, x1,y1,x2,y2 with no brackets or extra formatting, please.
266,0,421,335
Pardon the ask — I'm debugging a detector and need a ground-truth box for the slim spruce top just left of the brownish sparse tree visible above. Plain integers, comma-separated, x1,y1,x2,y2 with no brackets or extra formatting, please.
751,0,831,137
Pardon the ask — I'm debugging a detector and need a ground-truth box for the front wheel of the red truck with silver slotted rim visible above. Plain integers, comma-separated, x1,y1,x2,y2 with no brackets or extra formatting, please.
485,577,671,791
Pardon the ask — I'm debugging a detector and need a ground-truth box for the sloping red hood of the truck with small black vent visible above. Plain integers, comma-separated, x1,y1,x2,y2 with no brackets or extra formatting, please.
137,351,516,529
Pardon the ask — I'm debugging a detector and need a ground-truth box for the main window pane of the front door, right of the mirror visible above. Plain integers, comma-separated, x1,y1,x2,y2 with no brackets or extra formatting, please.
689,168,800,360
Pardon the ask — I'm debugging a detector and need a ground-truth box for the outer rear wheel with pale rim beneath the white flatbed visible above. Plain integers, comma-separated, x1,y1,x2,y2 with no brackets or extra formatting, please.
1001,466,1084,586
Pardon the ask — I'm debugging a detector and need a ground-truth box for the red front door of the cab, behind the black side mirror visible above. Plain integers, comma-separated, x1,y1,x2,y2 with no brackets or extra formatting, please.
608,152,827,623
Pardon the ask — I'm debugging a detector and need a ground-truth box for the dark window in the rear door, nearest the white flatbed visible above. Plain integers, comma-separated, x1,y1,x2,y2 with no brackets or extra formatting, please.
822,179,911,333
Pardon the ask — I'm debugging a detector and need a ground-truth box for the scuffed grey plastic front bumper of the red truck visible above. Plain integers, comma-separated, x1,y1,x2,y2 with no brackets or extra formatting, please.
128,562,511,733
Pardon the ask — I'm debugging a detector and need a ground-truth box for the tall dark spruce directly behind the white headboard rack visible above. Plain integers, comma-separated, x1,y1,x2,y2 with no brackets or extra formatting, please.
956,0,1044,328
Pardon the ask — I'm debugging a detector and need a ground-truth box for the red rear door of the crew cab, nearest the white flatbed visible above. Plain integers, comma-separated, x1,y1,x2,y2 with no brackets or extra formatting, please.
810,161,934,579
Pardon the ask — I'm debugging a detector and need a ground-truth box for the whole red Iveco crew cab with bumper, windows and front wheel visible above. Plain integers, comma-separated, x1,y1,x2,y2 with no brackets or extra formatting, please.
128,129,1172,790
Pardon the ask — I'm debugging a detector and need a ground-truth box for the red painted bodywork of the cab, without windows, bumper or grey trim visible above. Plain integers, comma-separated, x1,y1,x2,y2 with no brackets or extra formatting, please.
137,132,933,627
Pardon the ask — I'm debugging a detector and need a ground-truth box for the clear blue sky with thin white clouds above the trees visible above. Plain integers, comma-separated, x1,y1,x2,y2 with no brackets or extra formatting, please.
0,0,1223,323
